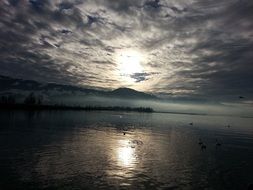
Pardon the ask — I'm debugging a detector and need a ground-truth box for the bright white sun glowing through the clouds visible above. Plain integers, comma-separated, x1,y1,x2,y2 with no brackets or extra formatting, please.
116,50,143,76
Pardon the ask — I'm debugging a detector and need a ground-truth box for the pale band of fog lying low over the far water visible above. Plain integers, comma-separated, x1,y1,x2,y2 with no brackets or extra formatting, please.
52,96,253,117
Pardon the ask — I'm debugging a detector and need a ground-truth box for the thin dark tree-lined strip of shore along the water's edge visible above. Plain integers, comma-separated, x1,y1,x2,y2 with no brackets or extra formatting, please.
0,104,154,113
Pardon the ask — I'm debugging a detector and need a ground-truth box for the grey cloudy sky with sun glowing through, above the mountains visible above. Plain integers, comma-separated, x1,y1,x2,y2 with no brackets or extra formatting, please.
0,0,253,101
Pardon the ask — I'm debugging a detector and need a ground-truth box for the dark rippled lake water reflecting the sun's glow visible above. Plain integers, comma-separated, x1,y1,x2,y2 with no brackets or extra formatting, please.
0,111,253,190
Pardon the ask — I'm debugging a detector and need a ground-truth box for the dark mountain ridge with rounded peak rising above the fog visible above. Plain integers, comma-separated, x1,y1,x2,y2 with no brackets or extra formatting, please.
0,76,157,99
